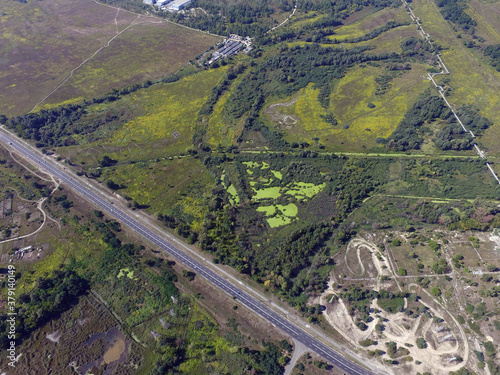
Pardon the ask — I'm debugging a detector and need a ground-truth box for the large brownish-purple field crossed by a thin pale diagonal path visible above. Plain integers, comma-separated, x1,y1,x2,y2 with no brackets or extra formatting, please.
0,0,217,115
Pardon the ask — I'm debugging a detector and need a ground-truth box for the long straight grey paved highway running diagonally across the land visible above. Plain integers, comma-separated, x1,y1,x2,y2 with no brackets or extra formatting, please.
0,131,375,375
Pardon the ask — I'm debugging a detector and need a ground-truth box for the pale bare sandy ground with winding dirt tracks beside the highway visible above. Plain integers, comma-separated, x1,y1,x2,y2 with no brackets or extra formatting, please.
322,234,469,375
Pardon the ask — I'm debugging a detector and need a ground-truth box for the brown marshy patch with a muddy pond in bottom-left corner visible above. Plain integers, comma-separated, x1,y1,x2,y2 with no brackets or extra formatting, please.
0,295,144,375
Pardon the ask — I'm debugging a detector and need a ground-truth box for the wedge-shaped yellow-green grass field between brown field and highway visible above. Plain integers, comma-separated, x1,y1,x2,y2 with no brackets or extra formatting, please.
59,68,225,165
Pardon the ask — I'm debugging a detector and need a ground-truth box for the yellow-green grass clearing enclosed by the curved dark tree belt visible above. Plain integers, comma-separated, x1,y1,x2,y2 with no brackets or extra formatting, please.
267,64,429,151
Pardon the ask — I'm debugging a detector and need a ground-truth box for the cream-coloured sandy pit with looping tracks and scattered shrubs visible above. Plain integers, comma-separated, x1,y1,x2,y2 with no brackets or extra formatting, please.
316,237,469,375
